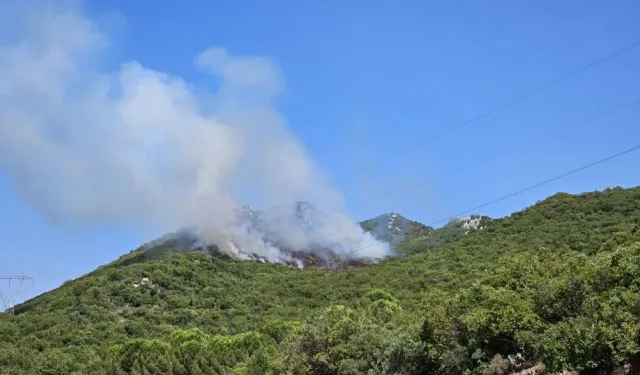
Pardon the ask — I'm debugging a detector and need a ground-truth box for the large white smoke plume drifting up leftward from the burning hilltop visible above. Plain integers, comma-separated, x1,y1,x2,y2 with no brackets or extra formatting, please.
0,2,388,259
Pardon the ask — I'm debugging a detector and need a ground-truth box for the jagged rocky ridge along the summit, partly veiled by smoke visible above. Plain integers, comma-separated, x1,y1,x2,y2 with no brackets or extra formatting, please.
137,201,491,269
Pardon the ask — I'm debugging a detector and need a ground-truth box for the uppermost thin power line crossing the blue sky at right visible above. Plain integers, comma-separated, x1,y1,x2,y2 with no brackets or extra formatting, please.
338,40,640,179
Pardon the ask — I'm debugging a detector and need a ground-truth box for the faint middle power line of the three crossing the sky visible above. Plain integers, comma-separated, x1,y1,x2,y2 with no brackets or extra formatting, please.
358,97,640,209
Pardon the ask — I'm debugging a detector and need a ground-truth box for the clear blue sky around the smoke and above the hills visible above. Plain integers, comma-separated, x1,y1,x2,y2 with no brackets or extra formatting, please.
0,0,640,299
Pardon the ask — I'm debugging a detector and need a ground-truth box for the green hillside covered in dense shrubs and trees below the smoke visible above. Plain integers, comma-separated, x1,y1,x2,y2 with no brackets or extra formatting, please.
0,188,640,375
